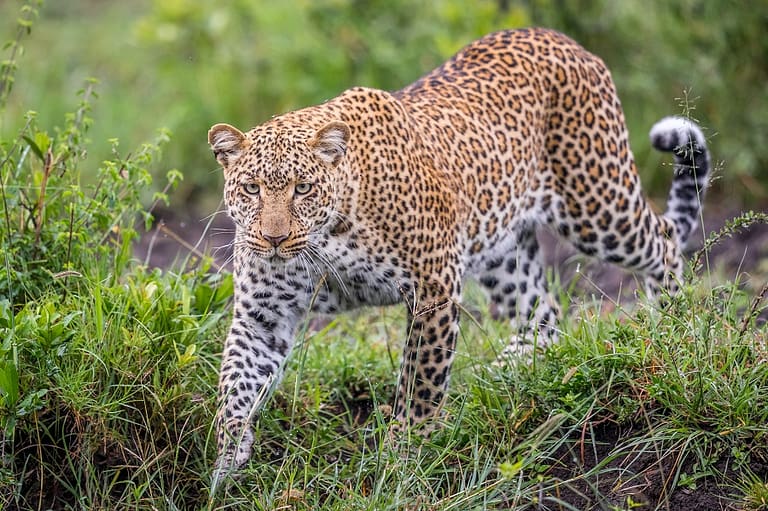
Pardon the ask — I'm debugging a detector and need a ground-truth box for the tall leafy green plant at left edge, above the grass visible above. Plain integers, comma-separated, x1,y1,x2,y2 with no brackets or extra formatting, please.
0,82,181,305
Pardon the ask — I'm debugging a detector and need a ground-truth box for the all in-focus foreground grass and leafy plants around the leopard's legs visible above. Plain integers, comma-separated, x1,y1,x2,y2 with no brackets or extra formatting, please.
0,2,768,511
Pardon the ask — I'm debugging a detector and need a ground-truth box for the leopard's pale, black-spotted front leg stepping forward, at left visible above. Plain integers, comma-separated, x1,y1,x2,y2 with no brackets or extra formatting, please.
214,273,308,482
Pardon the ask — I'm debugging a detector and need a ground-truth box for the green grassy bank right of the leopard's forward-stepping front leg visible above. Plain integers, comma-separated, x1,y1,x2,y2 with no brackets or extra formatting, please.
210,274,768,510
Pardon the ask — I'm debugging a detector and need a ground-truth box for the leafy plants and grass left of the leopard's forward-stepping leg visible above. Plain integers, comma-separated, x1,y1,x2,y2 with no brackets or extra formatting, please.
0,3,232,509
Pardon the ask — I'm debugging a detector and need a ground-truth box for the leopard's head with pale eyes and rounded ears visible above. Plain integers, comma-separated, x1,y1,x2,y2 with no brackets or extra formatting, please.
208,121,350,262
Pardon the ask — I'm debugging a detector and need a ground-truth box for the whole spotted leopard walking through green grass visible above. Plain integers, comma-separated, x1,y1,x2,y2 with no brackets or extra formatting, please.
208,28,711,480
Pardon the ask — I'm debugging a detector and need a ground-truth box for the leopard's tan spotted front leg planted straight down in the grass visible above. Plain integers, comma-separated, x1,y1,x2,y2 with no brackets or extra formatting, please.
395,284,459,426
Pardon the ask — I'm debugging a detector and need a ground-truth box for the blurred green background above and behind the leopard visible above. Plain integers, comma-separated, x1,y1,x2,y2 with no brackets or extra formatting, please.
0,0,768,215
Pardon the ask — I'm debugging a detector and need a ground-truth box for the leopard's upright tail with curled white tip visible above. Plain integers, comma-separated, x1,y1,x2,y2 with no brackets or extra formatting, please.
650,117,711,250
